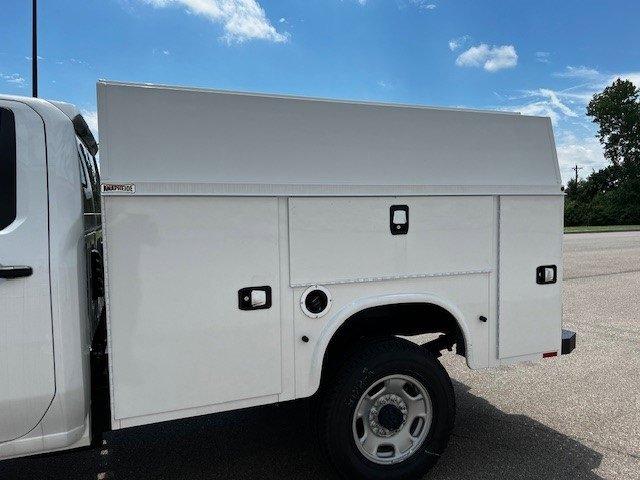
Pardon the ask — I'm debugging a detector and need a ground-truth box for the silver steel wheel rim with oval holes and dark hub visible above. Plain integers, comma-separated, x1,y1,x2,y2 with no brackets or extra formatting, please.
352,375,433,465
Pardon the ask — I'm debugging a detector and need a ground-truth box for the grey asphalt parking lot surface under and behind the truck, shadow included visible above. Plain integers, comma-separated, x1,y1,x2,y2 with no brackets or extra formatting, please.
0,232,640,480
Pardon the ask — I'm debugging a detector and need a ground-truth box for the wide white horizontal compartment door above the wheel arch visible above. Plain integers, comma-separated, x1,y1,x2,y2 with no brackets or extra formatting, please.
289,197,494,285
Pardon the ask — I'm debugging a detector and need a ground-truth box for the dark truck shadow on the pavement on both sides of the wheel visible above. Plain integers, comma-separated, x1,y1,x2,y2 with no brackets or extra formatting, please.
0,381,602,480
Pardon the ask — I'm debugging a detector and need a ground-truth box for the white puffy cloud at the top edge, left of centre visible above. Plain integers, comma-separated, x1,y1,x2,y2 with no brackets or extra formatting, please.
142,0,288,43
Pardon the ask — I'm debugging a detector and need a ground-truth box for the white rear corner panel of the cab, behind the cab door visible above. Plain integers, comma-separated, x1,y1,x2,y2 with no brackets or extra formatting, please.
39,101,93,451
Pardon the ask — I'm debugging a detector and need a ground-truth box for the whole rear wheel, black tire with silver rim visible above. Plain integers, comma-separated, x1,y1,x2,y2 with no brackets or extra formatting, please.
318,338,455,480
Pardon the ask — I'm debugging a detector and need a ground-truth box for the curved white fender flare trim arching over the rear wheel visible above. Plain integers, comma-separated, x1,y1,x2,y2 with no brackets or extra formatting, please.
309,293,473,391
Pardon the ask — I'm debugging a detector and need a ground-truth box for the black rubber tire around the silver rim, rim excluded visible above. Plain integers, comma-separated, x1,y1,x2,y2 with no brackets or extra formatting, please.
317,337,455,480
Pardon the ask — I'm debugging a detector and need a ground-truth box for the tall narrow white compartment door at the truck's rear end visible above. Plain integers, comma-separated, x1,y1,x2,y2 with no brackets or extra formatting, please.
498,197,563,358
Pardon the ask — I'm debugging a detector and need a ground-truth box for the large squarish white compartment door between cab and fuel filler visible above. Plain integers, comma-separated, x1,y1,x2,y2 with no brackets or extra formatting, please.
104,197,281,423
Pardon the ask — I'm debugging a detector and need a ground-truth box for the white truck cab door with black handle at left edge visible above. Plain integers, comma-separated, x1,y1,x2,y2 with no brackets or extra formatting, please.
0,100,55,442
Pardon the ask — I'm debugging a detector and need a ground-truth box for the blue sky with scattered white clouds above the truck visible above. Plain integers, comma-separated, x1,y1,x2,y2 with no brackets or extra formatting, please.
0,0,640,179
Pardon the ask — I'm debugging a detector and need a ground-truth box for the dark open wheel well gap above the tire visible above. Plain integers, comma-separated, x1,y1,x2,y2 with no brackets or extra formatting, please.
321,303,466,384
